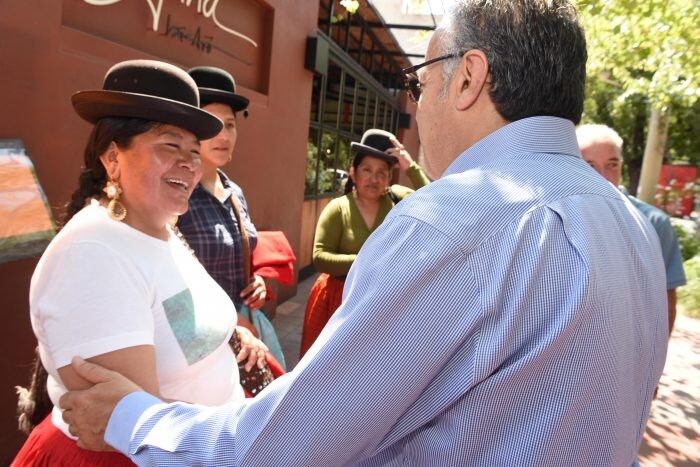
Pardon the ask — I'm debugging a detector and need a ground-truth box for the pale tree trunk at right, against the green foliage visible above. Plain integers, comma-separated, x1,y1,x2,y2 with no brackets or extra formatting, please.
637,107,670,204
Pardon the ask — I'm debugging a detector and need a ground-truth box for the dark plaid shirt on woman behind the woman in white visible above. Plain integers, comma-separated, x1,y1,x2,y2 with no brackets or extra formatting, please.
177,170,258,306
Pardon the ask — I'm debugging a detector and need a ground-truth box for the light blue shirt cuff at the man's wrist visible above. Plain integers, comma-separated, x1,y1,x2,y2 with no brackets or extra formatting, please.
104,391,163,456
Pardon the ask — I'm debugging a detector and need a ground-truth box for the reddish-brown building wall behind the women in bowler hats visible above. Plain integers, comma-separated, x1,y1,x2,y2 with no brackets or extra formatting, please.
0,0,318,465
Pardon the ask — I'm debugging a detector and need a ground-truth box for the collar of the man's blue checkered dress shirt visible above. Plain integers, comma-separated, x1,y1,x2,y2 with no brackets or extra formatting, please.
443,116,581,177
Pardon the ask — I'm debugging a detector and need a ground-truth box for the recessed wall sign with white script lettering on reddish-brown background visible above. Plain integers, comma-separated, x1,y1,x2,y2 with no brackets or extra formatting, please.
62,0,274,94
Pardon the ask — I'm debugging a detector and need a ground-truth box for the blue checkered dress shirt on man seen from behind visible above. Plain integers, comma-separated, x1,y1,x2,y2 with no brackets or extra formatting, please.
105,117,668,466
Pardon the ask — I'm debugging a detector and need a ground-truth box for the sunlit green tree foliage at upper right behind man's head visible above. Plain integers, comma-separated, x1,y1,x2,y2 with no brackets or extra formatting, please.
577,0,700,192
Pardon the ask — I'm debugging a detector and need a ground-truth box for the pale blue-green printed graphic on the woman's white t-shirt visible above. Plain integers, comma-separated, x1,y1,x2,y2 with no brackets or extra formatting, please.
163,289,227,365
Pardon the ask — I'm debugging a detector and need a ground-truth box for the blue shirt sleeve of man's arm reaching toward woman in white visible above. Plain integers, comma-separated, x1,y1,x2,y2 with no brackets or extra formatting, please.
61,217,479,465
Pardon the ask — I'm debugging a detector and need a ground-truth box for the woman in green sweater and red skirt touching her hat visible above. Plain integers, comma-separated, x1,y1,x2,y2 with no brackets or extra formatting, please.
299,129,430,358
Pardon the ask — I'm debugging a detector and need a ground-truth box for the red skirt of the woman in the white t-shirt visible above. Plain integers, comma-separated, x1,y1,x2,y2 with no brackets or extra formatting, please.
12,414,135,467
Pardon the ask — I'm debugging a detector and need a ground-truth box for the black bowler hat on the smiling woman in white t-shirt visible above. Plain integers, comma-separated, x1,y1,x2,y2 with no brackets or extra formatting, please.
71,60,223,140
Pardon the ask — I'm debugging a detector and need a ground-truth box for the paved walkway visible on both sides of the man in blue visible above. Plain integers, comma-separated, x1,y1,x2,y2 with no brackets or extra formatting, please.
274,275,700,467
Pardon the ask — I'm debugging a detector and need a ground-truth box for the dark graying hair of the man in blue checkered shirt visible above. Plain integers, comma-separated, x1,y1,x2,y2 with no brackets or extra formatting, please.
436,0,586,124
